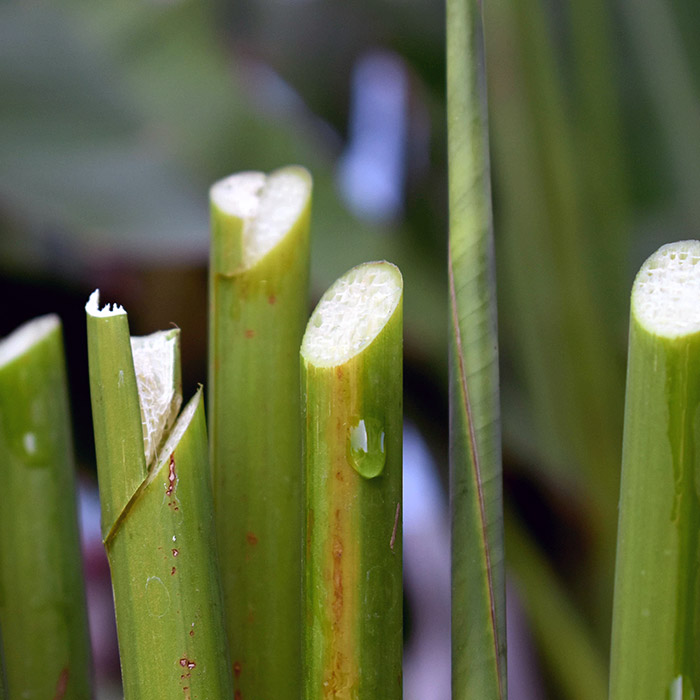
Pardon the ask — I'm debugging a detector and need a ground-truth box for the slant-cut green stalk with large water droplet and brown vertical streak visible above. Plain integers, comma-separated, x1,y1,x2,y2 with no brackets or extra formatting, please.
301,262,403,700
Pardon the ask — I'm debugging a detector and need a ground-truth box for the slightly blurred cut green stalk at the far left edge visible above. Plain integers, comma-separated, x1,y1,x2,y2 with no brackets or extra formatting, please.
0,316,92,700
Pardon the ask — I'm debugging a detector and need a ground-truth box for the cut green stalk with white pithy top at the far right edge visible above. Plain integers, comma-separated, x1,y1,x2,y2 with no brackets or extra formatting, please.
610,241,700,700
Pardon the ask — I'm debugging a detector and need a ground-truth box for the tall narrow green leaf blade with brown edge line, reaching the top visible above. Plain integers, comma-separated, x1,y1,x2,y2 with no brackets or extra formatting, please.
447,0,507,700
